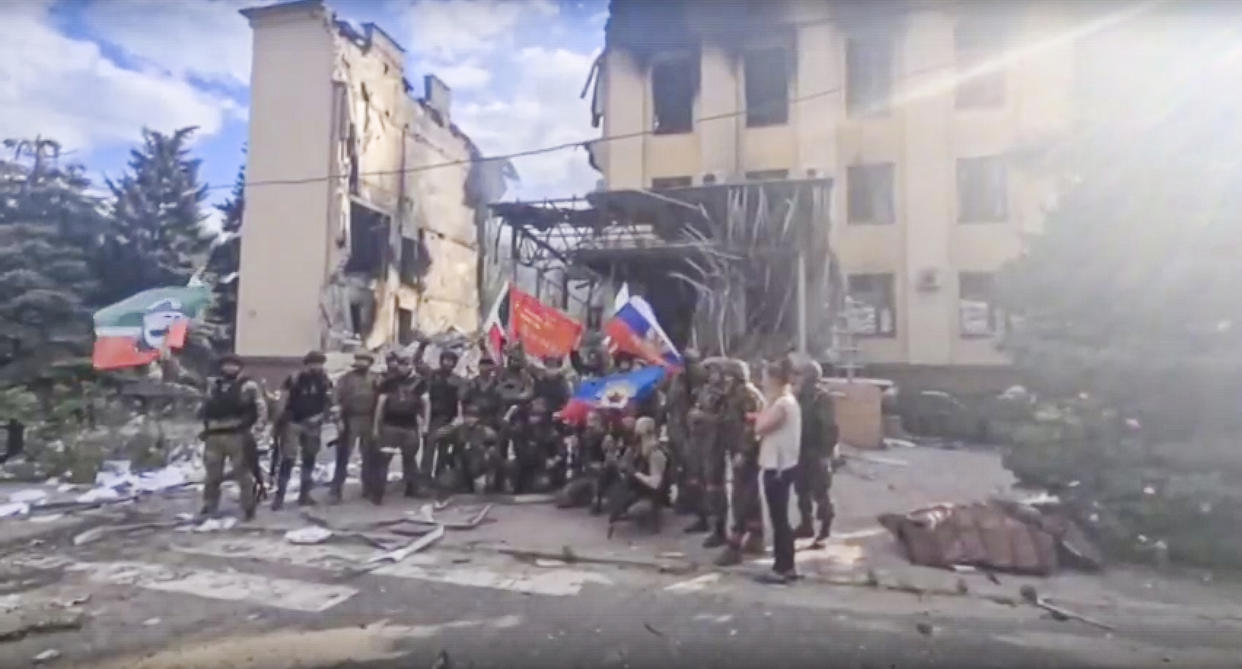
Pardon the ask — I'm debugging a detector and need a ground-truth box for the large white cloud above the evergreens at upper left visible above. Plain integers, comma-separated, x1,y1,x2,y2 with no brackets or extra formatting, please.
0,2,242,149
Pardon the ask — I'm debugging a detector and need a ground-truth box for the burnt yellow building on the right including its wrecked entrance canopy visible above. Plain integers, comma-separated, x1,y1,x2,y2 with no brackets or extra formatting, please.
534,0,1073,376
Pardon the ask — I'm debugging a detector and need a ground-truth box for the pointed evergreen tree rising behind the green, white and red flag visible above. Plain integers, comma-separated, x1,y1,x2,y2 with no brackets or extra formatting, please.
99,128,211,303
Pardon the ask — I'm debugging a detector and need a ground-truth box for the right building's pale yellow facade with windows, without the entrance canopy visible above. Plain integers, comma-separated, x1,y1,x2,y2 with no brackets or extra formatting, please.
591,0,1073,371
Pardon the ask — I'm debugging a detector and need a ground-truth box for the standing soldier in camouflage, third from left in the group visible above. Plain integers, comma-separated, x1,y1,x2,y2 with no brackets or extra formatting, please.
329,351,379,504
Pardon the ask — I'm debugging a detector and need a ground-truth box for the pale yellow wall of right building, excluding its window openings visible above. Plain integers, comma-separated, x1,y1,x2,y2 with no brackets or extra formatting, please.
600,0,1073,365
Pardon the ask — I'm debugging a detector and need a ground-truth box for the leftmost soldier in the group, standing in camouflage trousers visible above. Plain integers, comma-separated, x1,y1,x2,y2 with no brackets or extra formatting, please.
201,354,267,520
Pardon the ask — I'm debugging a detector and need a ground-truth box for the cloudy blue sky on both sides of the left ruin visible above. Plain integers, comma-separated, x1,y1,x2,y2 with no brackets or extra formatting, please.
0,0,607,228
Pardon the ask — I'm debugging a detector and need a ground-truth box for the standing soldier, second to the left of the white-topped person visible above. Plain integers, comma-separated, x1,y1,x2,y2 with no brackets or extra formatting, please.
686,365,728,539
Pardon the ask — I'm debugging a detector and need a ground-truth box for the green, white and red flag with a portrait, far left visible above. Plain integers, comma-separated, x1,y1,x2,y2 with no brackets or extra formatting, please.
91,285,211,370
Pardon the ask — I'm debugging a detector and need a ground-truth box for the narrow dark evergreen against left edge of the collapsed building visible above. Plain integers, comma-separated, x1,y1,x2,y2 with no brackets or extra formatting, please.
204,154,246,351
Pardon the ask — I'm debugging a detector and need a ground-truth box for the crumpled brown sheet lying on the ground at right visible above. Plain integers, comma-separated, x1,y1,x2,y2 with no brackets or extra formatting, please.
879,500,1099,576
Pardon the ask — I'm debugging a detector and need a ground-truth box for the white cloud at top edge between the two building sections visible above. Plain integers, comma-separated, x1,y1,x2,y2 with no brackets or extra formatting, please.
406,0,556,62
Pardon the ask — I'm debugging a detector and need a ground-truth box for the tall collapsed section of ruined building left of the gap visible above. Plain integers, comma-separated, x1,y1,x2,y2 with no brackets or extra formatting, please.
236,0,503,379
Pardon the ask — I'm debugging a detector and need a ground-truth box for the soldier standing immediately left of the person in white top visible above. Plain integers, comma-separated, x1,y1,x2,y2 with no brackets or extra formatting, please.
715,360,764,566
